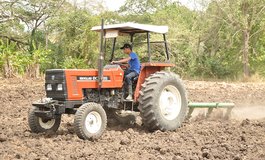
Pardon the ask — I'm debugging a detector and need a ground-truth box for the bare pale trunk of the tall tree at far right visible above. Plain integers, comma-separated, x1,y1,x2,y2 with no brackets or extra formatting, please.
243,29,250,78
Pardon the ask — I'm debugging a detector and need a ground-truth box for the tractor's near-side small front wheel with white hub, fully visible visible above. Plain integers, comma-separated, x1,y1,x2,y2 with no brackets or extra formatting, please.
74,102,107,140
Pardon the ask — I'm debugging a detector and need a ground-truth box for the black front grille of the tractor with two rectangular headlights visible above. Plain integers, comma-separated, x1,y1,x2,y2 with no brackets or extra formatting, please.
45,69,68,100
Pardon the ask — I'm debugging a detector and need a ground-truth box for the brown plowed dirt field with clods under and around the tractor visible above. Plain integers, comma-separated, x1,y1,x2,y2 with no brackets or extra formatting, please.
0,79,265,160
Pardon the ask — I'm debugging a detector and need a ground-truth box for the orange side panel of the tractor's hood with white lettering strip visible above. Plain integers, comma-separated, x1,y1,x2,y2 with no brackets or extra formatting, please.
65,68,124,100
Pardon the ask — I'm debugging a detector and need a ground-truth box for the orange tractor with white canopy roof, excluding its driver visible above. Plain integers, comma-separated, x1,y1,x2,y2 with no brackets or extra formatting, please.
28,22,188,139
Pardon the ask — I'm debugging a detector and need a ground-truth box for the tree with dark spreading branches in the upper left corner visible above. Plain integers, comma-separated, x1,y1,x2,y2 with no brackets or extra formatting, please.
0,0,64,77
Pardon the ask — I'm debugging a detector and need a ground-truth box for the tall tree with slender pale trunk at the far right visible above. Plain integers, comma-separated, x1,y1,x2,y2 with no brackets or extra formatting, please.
207,0,265,77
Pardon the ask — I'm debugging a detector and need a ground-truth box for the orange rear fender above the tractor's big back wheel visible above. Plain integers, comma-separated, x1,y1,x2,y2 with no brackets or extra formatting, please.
134,63,175,102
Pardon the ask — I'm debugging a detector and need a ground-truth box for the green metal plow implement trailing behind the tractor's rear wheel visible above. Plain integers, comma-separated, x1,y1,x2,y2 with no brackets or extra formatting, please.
187,102,235,119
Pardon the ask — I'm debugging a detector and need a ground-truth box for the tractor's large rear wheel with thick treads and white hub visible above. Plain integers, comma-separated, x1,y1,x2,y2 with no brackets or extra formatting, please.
139,71,188,131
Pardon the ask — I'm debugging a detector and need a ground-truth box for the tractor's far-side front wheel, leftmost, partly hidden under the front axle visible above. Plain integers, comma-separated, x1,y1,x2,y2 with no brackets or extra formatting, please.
28,106,61,133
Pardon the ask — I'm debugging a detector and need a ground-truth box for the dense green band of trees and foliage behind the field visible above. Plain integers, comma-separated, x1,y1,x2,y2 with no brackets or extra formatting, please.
0,0,265,78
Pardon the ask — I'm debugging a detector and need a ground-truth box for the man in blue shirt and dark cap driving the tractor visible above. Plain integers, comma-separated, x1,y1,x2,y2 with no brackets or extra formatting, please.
111,43,141,100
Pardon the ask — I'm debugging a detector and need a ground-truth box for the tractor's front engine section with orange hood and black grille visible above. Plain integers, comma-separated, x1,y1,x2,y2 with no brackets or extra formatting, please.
45,65,124,110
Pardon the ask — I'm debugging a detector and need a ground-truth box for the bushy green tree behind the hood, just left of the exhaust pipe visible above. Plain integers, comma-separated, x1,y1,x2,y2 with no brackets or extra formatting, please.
48,5,100,68
